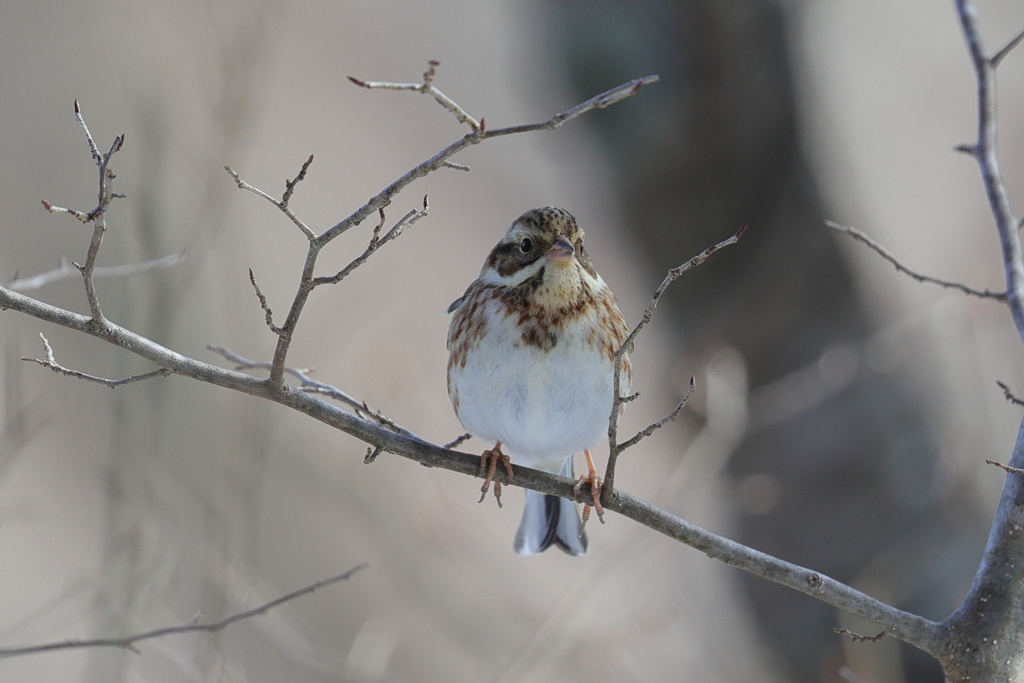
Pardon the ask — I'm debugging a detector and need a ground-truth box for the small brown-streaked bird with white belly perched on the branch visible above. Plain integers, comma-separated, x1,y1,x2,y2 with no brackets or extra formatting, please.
447,207,632,555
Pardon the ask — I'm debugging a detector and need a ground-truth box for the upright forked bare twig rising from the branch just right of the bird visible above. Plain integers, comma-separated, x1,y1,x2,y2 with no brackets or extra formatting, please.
603,225,746,495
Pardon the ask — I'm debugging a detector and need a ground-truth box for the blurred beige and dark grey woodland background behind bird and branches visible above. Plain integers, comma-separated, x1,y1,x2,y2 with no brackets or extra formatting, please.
0,0,1024,682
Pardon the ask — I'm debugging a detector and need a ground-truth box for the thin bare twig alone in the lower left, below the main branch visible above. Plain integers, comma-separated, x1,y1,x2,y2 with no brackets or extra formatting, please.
0,562,370,658
